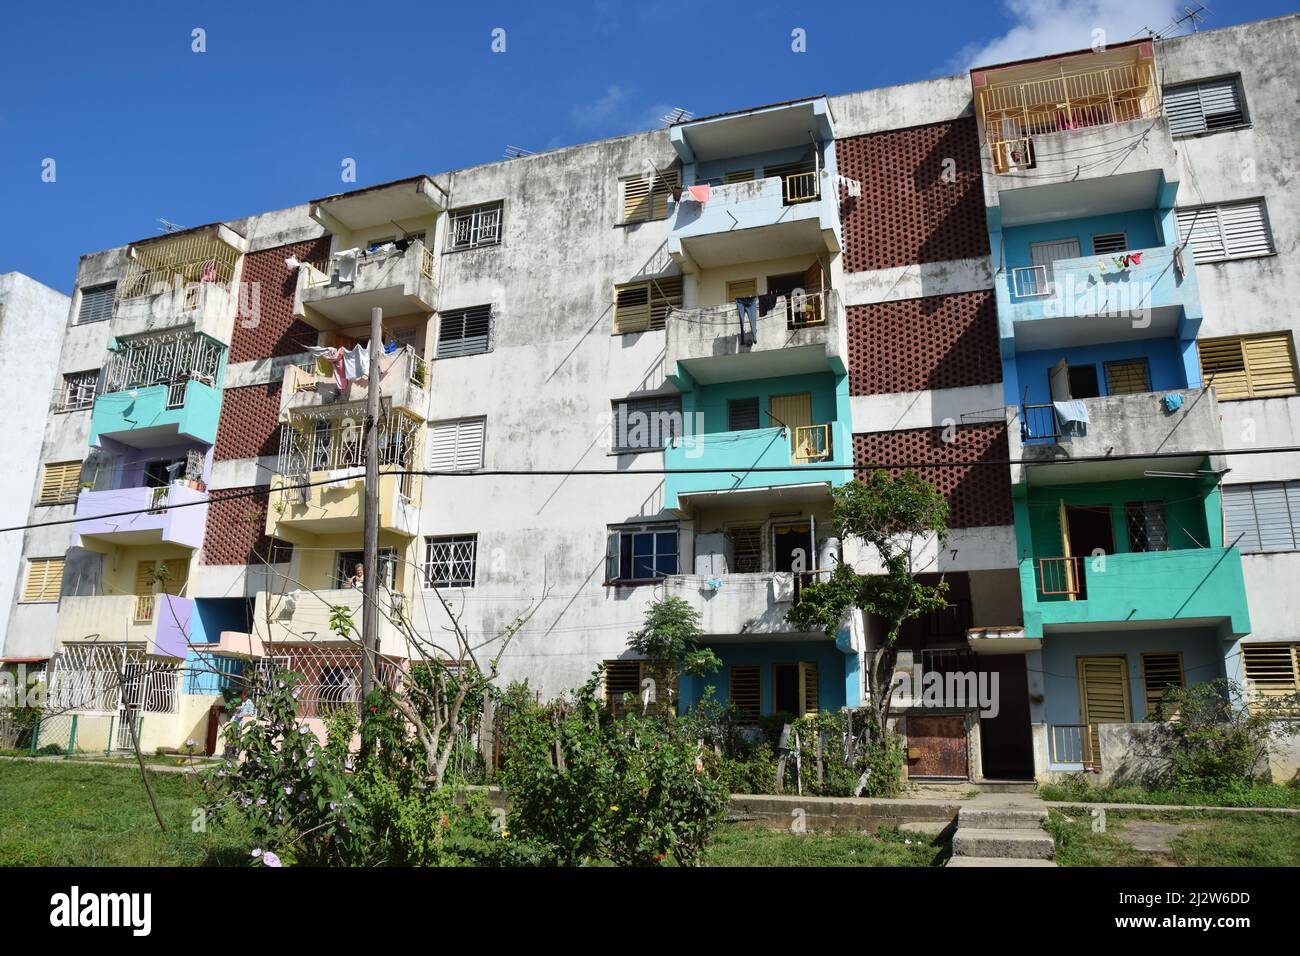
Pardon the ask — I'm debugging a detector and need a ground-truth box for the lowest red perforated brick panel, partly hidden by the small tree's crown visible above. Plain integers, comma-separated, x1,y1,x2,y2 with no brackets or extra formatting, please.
853,421,1011,528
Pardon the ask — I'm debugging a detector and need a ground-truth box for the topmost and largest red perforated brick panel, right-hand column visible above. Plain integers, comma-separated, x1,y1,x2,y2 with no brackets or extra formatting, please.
835,118,988,272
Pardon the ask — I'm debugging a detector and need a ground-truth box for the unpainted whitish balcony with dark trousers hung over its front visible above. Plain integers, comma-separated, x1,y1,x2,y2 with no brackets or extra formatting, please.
664,289,849,390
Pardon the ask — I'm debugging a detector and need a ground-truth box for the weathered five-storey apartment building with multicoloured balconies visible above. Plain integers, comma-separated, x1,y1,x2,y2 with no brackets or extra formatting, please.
4,17,1300,780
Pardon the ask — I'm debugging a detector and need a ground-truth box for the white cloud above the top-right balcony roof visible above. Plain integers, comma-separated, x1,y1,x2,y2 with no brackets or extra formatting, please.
949,0,1183,73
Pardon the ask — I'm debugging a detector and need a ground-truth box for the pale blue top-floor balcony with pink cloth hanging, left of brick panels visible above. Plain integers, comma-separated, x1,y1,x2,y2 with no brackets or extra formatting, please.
668,169,840,272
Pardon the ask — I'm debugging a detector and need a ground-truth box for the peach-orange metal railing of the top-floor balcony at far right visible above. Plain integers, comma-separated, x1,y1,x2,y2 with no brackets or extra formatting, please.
979,61,1161,173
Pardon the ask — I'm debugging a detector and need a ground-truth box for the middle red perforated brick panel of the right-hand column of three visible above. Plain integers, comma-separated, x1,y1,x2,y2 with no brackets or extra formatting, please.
848,291,1002,395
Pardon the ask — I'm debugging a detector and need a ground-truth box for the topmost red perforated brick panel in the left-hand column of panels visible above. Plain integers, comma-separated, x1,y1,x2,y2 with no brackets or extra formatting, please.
230,235,329,362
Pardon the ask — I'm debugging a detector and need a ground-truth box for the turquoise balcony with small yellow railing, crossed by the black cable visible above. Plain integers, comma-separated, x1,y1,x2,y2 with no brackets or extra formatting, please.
663,421,853,514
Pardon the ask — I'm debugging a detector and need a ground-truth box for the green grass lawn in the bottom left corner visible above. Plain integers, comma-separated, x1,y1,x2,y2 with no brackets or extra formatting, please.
0,761,248,866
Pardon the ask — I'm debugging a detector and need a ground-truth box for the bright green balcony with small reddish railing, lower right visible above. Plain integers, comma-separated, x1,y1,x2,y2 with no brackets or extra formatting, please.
1021,548,1251,637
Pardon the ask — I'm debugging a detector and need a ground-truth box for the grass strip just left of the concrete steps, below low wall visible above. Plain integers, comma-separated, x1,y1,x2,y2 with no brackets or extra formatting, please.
705,826,946,866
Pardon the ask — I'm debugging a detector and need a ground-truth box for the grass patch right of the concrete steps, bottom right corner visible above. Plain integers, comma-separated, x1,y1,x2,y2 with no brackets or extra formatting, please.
1048,809,1300,866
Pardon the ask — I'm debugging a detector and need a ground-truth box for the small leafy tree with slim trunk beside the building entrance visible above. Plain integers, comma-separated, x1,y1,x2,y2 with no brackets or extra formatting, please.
787,468,948,740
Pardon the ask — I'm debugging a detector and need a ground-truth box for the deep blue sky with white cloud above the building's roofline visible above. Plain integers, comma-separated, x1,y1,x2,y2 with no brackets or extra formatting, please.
0,0,1295,293
